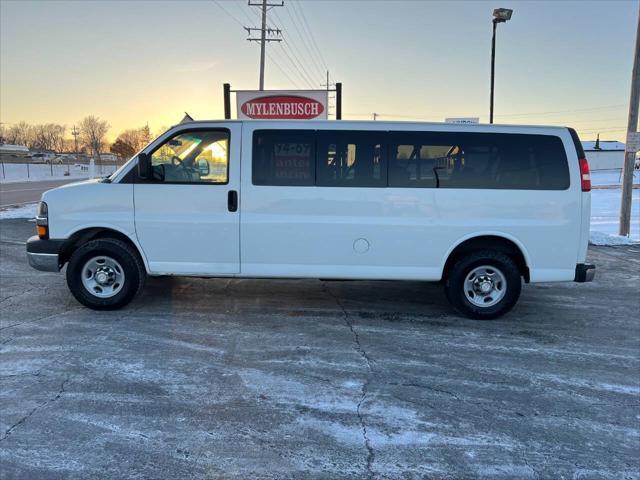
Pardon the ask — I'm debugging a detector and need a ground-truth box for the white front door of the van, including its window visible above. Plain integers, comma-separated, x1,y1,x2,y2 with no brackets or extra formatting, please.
134,123,242,275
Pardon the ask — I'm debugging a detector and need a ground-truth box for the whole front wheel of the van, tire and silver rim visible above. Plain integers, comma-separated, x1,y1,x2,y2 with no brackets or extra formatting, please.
67,238,146,310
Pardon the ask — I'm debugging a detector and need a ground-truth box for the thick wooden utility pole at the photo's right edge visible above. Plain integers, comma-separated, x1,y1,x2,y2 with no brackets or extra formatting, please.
618,3,640,236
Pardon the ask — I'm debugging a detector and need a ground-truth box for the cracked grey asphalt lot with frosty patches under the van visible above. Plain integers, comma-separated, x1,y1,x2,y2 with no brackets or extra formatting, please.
0,220,640,479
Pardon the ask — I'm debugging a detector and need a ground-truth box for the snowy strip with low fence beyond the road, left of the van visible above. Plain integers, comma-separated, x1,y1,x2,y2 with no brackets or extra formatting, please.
0,162,118,182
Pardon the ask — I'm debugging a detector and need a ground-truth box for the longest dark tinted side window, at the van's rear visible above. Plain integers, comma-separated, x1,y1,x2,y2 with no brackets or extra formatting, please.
389,132,569,190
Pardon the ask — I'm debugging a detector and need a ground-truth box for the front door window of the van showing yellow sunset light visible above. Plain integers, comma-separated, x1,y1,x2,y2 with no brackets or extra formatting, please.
151,130,229,184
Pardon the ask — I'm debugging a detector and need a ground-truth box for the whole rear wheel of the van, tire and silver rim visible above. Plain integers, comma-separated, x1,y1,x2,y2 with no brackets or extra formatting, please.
445,250,522,320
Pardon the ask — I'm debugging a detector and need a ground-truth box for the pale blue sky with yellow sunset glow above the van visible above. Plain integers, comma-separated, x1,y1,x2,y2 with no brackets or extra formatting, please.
0,0,638,140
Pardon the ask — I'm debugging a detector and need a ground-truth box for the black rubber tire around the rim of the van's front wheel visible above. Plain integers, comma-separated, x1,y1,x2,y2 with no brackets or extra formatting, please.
67,238,146,310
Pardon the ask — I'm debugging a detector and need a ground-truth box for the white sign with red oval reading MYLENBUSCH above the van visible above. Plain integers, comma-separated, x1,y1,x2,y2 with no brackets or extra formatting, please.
236,90,328,120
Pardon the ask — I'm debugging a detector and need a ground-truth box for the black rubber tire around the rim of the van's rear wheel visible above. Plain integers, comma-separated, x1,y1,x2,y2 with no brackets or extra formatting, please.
445,250,522,320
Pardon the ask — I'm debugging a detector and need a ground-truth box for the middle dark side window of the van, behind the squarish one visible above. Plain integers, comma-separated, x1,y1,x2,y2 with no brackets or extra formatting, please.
316,131,387,187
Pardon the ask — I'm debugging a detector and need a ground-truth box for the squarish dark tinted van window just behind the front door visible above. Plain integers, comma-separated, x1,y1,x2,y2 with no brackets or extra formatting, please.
252,130,316,186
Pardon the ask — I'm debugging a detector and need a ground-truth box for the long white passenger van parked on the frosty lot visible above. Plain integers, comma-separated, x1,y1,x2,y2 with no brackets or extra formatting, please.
27,120,595,319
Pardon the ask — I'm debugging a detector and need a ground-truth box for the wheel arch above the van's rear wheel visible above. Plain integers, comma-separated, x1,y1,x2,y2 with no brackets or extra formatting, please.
442,232,531,283
